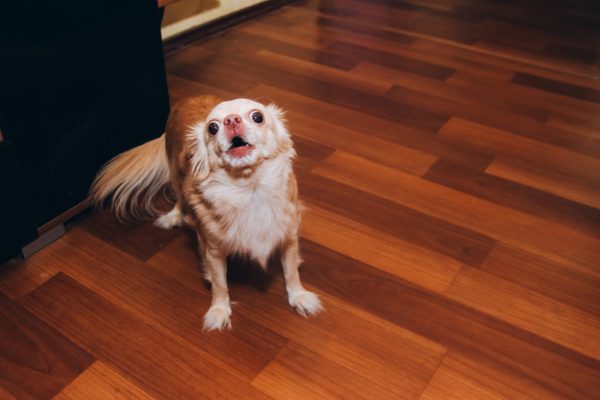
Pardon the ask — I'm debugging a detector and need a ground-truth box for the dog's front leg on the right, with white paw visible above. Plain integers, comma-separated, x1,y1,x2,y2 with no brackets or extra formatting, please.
281,238,323,317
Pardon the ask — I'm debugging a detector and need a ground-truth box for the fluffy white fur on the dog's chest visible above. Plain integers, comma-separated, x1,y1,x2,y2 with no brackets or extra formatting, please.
201,162,296,265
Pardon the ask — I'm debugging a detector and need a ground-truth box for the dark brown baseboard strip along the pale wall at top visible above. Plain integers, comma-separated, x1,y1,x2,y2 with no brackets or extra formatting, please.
163,0,297,54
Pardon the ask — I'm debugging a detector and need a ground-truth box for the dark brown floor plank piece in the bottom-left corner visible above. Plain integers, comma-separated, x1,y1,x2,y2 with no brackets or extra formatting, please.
0,293,94,399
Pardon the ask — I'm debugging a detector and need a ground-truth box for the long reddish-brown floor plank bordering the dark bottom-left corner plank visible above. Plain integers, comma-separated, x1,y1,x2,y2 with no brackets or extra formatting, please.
23,273,265,399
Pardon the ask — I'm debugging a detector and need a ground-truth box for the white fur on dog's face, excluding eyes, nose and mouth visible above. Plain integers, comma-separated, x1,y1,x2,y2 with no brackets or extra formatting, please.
206,99,278,168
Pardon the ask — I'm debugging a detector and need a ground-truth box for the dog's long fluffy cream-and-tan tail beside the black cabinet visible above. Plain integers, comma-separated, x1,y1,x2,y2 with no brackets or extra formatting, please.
90,134,169,219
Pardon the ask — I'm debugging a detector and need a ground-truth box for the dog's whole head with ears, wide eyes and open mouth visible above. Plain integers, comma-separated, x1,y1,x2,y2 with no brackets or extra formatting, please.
192,99,294,177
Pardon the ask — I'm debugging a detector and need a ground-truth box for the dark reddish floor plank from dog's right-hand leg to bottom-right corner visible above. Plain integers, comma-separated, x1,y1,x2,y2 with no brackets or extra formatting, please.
302,241,600,399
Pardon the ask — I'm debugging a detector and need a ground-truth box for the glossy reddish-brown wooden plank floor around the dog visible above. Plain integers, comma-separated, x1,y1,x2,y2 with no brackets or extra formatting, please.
0,0,600,400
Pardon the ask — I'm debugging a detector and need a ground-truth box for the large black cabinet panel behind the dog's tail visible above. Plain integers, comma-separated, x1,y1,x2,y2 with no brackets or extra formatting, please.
0,0,169,229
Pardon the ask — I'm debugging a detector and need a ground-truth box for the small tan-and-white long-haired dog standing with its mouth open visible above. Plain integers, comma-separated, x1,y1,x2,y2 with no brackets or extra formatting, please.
90,96,322,331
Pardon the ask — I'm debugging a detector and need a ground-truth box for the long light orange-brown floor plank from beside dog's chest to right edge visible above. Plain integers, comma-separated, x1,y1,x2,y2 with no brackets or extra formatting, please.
313,151,600,273
